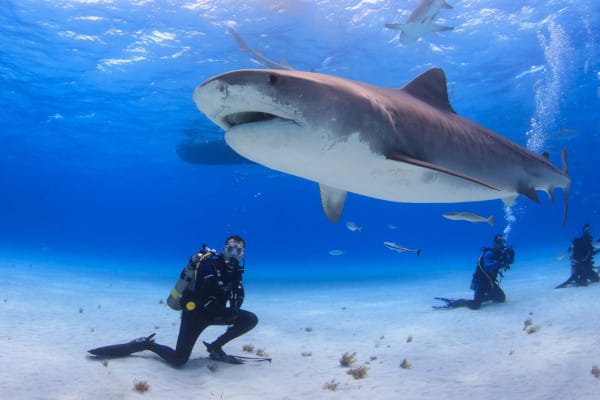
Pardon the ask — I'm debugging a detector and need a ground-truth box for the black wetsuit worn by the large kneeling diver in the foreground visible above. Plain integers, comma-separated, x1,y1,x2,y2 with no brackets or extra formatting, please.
147,255,258,366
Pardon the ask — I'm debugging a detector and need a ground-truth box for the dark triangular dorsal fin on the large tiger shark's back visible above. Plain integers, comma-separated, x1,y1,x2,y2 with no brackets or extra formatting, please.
402,68,456,114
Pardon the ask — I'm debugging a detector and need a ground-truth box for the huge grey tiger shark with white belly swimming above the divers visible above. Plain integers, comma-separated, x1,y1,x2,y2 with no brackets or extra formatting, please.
193,68,570,222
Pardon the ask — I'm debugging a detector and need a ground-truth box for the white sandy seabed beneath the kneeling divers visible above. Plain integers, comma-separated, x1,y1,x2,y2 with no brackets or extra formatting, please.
0,256,600,400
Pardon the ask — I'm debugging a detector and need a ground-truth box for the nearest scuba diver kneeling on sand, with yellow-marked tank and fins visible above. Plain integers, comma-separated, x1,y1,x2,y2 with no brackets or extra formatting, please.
89,235,270,367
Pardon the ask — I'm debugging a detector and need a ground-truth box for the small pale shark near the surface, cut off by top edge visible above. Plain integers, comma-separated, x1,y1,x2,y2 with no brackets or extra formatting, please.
385,0,454,46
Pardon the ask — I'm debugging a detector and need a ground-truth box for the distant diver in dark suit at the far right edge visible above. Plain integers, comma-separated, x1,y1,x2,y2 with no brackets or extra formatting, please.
555,224,600,289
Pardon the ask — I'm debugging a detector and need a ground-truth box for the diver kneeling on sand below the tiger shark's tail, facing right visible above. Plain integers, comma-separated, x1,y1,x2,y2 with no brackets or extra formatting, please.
433,234,515,310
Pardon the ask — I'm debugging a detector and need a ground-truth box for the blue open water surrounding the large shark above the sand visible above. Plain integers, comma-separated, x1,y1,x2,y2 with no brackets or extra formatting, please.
0,0,600,280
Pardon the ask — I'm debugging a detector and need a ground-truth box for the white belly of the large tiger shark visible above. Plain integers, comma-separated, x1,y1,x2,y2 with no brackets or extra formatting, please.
225,122,515,203
